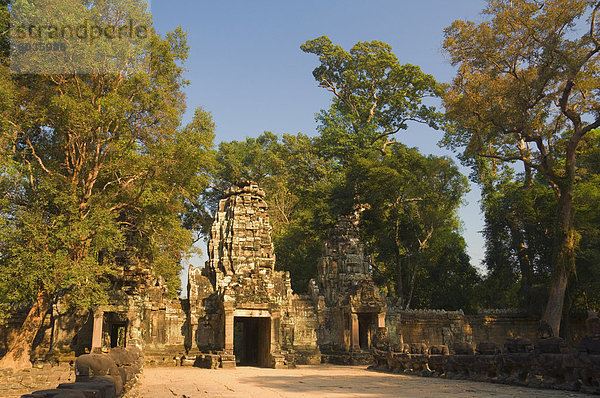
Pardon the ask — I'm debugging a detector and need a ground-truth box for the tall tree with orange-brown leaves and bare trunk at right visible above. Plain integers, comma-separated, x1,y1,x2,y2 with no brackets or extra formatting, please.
444,0,600,334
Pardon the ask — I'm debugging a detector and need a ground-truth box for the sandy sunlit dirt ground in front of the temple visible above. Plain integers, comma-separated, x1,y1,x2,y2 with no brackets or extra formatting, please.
127,365,585,398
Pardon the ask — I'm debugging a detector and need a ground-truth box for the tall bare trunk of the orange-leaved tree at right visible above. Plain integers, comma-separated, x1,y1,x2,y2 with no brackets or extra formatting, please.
542,188,577,336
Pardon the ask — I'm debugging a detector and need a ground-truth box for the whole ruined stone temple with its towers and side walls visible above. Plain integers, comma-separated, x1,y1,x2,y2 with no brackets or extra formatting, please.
0,182,600,394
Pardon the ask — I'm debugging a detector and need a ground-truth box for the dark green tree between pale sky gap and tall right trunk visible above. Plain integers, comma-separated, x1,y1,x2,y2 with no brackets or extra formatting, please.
481,172,556,314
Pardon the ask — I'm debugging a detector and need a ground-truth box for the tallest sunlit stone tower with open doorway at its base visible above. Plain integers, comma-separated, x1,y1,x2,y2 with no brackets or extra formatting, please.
189,183,316,368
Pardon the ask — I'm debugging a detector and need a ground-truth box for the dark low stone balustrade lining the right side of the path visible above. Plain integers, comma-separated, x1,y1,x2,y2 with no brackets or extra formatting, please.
372,338,600,394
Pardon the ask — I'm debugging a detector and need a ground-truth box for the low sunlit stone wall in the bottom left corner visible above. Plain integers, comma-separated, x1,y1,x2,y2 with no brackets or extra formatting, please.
0,363,75,398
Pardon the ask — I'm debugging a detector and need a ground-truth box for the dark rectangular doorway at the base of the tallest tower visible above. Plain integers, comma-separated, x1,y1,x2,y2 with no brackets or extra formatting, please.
233,317,271,367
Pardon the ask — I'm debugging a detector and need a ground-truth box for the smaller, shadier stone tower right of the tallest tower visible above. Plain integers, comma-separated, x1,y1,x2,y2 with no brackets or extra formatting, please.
309,216,386,363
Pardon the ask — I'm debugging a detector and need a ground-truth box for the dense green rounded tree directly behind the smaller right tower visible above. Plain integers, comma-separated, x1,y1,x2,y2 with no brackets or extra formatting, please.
347,144,467,308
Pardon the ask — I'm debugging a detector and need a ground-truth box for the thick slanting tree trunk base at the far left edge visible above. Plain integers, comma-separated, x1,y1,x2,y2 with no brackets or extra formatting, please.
0,291,51,370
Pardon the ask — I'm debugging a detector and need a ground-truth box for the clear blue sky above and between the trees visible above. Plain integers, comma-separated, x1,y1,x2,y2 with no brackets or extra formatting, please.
151,0,485,276
